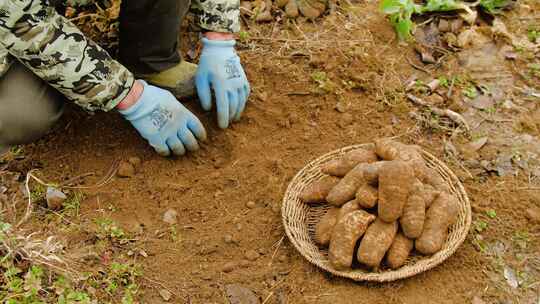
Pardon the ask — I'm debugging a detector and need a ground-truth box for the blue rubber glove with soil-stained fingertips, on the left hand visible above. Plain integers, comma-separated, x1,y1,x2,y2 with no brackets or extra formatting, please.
119,80,206,156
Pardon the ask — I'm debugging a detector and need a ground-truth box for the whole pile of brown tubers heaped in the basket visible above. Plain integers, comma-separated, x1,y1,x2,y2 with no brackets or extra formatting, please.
300,139,458,270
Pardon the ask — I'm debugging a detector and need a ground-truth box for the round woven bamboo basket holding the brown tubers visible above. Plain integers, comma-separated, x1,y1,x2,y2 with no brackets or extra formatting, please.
282,144,471,282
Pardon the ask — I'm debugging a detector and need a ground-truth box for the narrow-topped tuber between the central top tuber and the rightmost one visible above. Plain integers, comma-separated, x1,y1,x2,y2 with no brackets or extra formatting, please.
399,180,426,239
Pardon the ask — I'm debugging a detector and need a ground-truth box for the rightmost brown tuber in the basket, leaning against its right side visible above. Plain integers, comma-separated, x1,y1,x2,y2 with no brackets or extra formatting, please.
415,192,458,254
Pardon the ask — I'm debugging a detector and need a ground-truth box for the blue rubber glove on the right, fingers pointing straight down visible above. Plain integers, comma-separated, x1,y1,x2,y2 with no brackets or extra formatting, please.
195,38,249,129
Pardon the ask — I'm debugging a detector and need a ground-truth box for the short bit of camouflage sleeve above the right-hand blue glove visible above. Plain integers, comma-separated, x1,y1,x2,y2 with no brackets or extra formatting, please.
191,0,240,33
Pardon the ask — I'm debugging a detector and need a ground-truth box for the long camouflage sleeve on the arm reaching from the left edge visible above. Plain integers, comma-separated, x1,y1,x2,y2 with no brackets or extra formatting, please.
0,0,134,111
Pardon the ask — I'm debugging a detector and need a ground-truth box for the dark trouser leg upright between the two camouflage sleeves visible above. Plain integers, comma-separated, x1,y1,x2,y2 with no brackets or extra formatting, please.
119,0,190,74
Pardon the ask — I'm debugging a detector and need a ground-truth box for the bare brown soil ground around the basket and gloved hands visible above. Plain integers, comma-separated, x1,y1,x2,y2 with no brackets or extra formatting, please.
2,1,540,304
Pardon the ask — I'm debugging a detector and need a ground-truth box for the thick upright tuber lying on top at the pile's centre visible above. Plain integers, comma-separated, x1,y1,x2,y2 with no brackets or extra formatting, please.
378,160,414,223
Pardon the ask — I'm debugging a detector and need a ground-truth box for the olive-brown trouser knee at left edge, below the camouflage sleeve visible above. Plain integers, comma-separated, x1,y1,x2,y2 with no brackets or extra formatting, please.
0,62,64,152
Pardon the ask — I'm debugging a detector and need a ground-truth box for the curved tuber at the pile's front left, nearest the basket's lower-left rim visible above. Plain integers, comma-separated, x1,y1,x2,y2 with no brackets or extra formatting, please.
328,210,376,269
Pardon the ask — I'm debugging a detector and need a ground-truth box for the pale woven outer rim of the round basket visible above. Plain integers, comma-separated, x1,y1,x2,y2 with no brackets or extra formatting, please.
281,143,472,283
